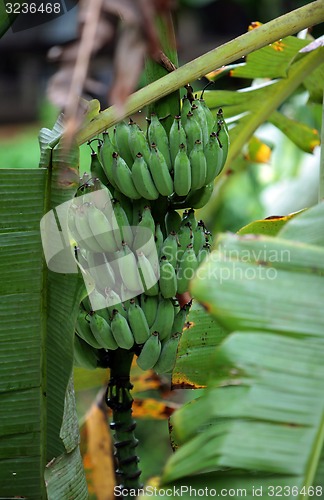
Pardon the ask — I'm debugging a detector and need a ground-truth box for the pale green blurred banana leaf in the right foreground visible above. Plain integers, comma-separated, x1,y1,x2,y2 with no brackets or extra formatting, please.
157,204,324,498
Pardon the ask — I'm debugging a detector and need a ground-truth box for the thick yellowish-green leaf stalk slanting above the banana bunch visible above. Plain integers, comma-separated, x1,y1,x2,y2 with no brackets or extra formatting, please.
77,0,324,144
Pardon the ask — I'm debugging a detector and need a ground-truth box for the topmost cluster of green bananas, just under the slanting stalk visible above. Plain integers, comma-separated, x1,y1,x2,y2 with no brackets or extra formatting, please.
92,97,229,208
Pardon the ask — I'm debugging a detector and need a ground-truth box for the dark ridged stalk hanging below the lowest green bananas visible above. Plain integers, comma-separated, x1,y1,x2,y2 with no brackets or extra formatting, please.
106,349,142,498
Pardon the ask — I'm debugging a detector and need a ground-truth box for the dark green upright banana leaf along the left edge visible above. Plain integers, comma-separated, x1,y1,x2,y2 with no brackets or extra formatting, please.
0,119,88,500
